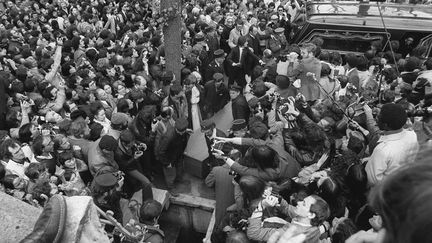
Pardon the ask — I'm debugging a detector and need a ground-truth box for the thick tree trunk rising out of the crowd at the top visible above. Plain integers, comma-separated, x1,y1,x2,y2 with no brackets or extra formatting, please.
160,0,182,81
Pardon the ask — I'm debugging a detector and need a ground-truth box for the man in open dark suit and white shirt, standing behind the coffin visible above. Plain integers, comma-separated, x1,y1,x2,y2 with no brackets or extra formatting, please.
227,36,263,88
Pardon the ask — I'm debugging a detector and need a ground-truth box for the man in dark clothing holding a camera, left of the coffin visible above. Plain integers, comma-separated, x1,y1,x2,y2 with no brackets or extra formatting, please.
114,130,153,202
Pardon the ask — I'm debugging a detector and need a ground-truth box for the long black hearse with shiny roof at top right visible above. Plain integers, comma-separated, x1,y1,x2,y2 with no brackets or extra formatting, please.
294,1,432,57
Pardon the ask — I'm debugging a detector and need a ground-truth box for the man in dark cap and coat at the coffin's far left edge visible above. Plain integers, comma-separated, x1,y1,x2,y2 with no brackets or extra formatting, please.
203,73,229,118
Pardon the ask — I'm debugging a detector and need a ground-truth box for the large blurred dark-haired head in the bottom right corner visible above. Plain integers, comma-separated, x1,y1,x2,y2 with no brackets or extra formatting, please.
369,160,432,243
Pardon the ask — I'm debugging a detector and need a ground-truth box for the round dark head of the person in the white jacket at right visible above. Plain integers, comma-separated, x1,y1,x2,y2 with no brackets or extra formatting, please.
379,103,408,130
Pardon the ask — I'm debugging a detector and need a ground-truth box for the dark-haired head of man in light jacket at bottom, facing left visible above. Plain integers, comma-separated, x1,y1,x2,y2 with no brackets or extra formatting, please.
294,195,330,226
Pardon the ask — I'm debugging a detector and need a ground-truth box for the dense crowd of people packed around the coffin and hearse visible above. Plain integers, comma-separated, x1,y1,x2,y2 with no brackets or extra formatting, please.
0,0,432,243
